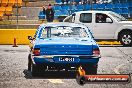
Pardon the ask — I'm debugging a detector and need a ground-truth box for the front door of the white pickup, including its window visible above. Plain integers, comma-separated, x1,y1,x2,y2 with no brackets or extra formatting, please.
93,13,118,39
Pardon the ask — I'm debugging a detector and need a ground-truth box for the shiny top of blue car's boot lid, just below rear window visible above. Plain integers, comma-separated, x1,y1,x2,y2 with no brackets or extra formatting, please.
36,38,93,45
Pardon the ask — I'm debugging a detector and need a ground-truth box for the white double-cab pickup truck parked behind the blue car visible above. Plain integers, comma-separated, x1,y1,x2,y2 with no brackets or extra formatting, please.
63,11,132,46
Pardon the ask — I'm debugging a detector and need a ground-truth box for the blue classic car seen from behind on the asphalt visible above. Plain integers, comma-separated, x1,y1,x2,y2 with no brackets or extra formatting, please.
28,22,100,76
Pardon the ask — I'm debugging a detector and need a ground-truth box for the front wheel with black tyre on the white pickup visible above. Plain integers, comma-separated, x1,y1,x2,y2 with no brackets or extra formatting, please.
119,31,132,46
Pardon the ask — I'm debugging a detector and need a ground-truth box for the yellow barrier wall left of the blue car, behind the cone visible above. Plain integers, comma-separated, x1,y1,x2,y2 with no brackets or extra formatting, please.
0,29,36,45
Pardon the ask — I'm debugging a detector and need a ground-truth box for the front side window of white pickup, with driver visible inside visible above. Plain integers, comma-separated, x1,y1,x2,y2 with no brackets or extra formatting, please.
95,13,112,23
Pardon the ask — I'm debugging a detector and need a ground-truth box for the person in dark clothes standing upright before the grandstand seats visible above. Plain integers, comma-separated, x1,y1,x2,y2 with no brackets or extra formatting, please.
45,4,54,22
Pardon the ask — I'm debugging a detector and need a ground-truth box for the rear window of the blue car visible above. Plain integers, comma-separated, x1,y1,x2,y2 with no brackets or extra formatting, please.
40,26,88,38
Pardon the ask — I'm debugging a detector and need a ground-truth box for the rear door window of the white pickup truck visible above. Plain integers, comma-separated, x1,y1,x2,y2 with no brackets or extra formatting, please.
80,13,92,23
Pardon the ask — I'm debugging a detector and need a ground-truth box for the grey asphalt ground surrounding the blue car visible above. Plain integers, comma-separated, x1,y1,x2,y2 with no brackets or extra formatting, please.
0,45,132,88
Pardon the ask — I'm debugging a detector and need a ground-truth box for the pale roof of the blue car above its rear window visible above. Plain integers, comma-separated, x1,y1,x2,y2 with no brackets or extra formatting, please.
41,22,86,27
